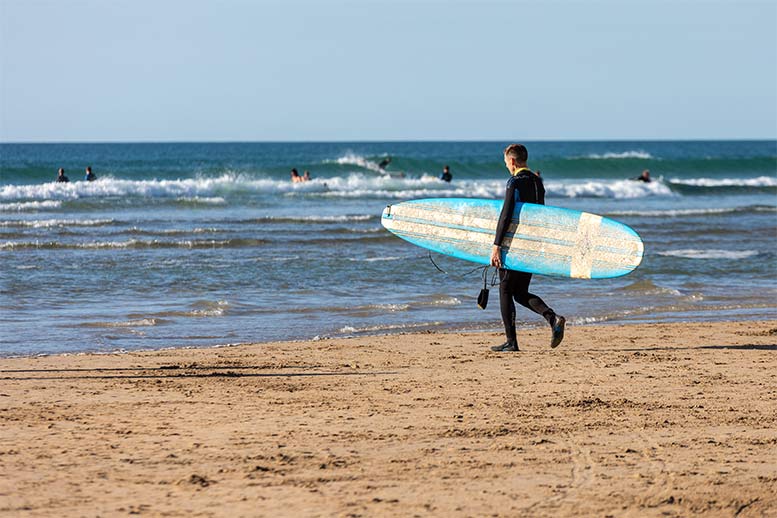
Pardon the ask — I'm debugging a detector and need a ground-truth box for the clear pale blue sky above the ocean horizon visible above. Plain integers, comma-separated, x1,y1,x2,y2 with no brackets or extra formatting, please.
0,0,777,142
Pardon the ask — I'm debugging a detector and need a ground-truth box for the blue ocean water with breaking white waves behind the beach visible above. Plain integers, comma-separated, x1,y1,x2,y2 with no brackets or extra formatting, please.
0,141,777,356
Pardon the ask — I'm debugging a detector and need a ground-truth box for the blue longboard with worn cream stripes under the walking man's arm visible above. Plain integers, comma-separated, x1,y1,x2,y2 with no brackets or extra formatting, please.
381,198,644,279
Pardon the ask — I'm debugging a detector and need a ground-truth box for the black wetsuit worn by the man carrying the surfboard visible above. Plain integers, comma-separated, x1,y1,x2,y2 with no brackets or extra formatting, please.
494,169,555,343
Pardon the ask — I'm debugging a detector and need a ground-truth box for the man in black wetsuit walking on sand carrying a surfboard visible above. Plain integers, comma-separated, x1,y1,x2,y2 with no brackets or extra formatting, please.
491,144,566,352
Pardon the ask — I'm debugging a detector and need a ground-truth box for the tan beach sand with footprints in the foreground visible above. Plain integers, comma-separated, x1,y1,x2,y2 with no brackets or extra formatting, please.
0,321,777,517
